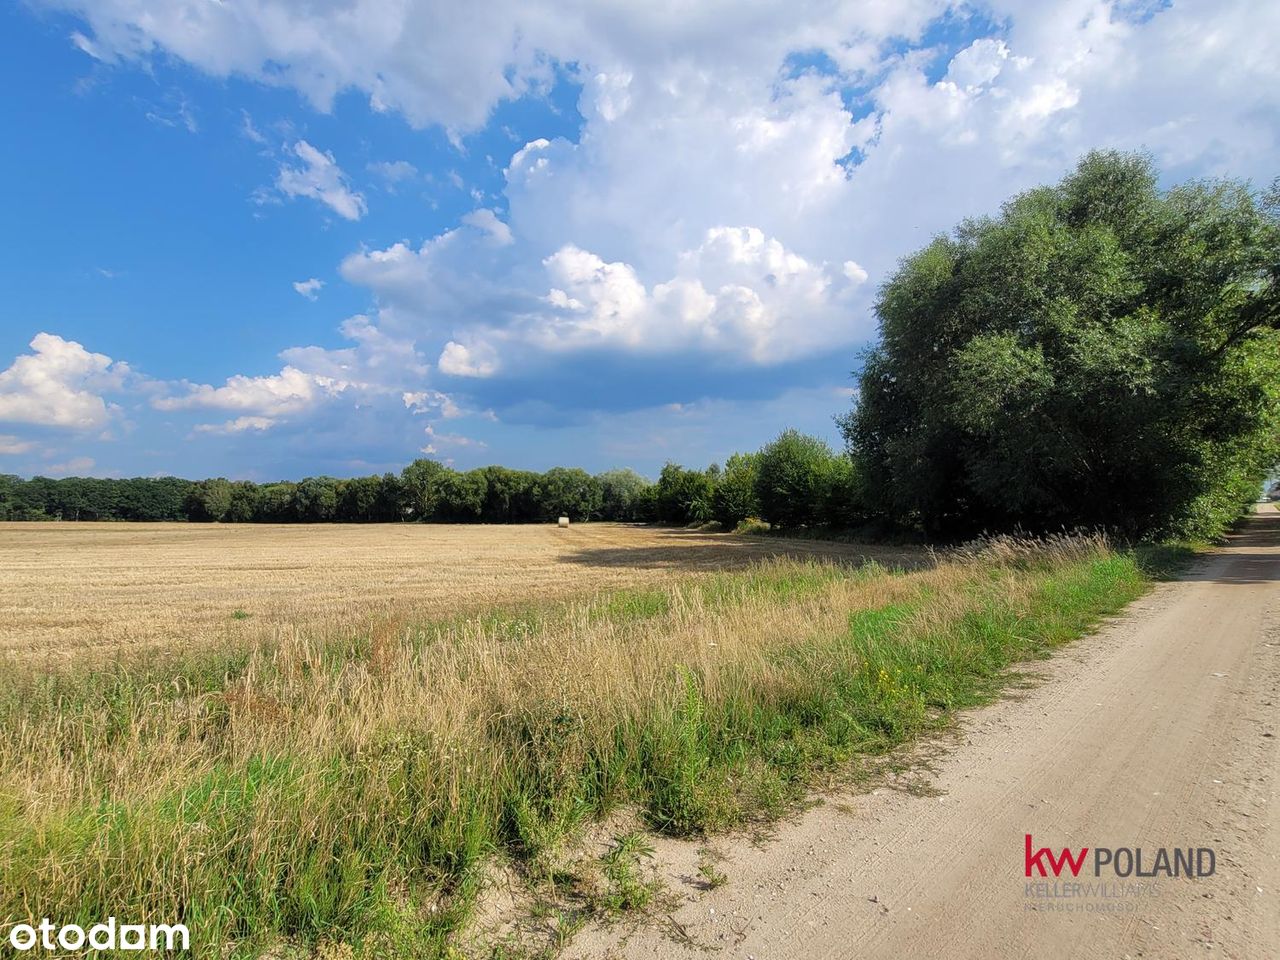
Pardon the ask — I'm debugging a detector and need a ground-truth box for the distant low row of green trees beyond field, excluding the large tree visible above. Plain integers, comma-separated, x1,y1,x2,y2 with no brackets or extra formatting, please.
0,430,856,526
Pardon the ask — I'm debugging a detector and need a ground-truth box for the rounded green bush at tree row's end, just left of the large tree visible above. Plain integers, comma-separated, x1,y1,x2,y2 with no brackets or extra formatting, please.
755,430,837,526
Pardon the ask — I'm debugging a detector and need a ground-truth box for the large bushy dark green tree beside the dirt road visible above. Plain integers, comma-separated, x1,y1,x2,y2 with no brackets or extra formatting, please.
841,152,1280,536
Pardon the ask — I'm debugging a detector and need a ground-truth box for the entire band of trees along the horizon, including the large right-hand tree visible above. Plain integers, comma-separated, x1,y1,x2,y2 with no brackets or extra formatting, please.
0,152,1280,540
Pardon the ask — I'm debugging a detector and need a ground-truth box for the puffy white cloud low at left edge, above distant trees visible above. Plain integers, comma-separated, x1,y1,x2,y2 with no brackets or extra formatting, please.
0,333,132,430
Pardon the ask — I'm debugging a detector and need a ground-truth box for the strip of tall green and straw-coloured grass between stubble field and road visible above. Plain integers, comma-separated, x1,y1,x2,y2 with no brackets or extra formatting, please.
0,539,1146,957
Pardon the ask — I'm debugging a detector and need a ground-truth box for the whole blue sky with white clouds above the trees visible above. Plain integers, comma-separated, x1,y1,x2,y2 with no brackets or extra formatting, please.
0,0,1280,480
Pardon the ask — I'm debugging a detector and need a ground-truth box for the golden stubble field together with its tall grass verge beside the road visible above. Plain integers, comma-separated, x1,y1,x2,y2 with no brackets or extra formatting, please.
0,524,1148,960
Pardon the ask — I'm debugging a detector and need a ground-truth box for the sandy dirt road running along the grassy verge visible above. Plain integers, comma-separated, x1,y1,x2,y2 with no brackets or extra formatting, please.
570,507,1280,960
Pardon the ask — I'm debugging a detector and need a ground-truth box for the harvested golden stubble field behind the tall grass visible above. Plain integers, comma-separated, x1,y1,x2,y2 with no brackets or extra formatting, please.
0,524,915,662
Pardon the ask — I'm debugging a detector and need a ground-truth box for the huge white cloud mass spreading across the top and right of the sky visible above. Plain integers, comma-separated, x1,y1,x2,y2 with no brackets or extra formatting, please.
32,0,1280,445
